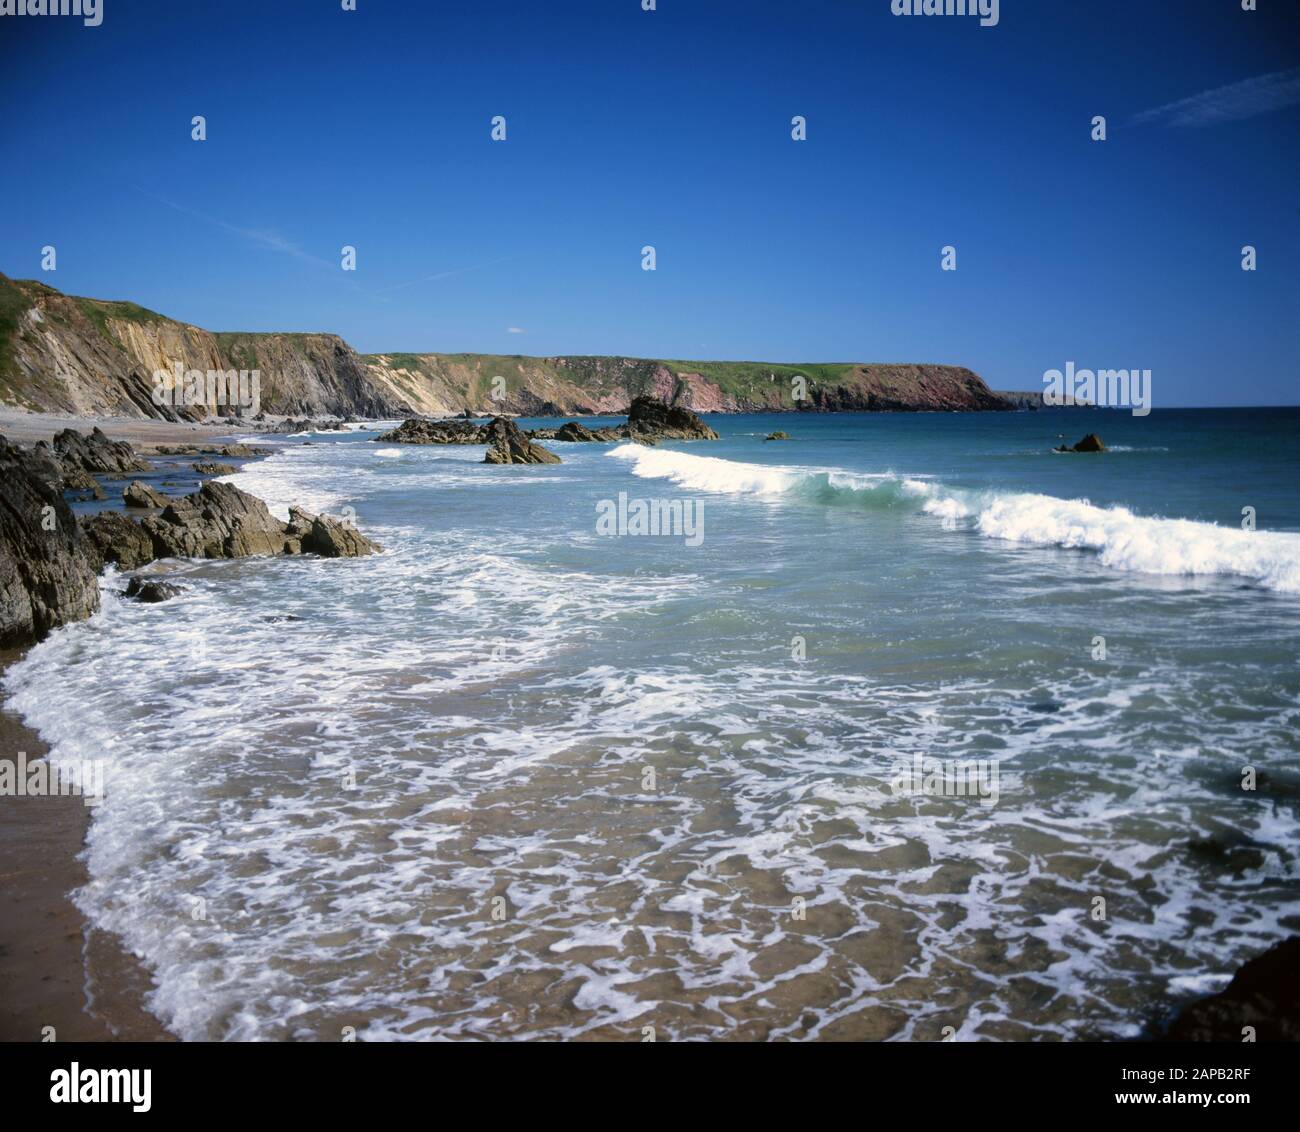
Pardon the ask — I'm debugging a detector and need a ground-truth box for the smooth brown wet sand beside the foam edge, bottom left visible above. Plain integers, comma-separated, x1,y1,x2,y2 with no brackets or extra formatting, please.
0,651,169,1041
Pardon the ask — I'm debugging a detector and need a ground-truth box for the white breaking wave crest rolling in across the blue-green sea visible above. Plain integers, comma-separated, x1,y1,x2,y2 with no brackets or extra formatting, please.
610,444,1300,593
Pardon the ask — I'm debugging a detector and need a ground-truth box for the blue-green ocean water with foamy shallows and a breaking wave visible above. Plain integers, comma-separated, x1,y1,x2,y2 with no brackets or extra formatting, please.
7,409,1300,1041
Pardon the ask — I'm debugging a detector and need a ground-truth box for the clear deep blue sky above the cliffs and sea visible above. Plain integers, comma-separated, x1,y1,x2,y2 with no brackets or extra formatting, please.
0,0,1300,408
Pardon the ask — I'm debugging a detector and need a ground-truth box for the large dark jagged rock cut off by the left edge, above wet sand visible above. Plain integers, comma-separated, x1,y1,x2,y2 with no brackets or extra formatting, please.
0,437,99,646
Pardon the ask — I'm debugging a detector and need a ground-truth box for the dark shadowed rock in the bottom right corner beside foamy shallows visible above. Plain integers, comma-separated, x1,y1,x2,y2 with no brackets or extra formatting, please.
1165,936,1300,1042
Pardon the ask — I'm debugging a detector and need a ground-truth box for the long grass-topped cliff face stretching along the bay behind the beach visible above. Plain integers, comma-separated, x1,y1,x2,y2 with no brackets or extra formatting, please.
0,276,1011,420
